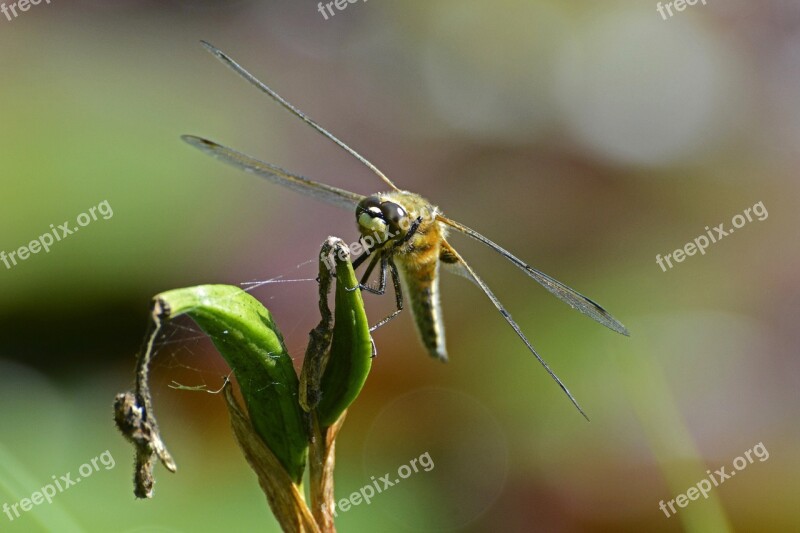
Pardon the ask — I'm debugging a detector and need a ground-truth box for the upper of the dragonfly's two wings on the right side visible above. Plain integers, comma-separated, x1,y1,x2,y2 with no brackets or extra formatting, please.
436,215,629,335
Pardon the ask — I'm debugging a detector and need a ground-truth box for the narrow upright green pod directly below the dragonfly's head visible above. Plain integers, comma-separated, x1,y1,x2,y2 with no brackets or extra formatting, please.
317,243,373,427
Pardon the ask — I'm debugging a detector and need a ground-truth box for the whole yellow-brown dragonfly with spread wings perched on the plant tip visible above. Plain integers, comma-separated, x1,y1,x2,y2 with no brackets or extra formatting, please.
181,41,629,420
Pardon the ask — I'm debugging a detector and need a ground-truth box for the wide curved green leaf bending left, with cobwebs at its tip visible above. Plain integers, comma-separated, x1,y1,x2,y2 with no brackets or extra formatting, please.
155,285,308,484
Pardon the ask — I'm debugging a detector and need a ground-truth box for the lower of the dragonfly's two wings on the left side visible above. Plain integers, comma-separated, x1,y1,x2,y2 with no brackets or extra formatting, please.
181,135,364,211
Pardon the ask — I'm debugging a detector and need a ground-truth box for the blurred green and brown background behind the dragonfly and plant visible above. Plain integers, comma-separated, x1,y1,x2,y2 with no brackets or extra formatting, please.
0,0,800,532
